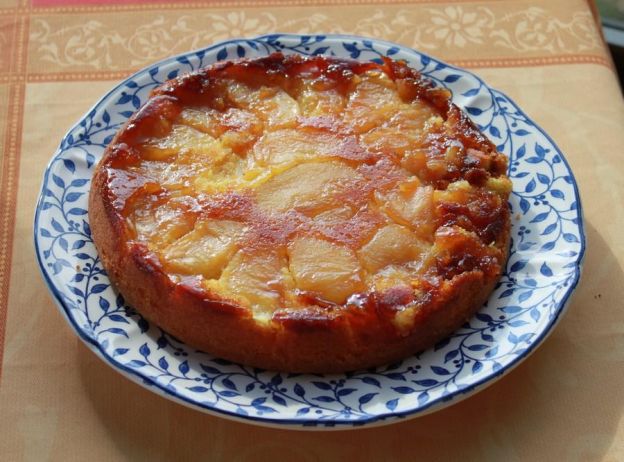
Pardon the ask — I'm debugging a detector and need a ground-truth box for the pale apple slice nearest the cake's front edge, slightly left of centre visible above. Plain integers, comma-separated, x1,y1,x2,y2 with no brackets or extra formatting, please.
220,250,293,318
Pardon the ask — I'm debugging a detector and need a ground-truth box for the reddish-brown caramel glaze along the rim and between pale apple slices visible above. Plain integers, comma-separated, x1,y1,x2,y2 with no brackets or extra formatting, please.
97,53,509,336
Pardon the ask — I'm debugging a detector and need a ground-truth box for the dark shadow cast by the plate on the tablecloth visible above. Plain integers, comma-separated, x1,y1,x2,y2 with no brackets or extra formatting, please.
79,222,624,461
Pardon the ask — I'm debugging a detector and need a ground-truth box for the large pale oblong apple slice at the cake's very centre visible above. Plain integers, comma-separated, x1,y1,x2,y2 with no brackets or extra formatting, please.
256,162,358,211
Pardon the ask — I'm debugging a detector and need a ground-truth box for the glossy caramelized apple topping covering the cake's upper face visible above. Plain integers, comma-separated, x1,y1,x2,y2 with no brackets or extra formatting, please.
104,54,510,329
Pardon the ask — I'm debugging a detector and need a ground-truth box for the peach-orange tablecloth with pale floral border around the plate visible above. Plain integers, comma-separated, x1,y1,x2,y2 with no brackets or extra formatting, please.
0,0,624,461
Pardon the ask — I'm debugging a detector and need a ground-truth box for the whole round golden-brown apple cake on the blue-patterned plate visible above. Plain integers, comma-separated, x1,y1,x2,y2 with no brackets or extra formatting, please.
89,53,511,373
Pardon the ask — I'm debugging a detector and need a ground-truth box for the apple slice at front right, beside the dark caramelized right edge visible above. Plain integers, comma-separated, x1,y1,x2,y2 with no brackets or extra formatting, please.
358,224,429,273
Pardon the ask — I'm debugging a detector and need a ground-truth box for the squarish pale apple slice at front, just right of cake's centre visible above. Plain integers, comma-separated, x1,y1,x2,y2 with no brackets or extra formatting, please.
288,238,365,303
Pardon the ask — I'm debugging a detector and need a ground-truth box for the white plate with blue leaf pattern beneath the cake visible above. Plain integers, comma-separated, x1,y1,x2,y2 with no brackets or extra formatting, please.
35,34,585,429
